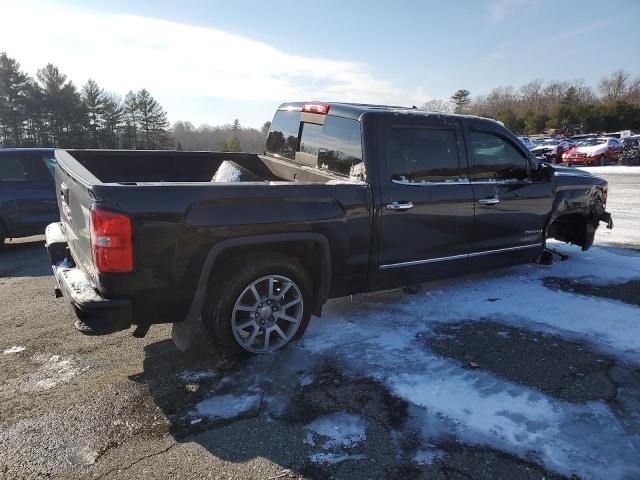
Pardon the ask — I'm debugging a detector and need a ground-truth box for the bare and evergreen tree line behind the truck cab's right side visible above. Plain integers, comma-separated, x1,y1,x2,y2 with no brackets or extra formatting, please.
422,70,640,135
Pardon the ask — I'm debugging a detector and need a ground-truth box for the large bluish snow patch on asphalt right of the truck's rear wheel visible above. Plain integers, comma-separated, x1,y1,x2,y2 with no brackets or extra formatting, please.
296,244,640,479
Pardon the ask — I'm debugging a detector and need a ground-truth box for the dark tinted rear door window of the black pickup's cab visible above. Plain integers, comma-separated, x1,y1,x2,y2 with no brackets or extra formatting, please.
385,127,463,184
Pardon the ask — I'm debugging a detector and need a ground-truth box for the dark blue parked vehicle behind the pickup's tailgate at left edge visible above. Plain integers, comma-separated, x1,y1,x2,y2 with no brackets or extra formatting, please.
0,148,60,246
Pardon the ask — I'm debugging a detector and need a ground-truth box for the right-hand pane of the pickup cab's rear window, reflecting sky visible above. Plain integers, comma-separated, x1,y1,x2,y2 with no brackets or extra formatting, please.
296,115,364,180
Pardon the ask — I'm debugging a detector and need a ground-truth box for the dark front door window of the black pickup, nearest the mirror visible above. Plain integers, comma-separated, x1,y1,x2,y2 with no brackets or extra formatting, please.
469,131,529,181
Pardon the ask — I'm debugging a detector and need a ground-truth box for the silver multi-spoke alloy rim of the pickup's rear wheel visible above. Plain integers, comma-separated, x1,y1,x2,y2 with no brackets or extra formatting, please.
231,275,304,353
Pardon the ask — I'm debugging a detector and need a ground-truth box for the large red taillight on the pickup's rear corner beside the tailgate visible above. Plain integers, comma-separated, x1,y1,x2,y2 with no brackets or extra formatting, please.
91,207,133,273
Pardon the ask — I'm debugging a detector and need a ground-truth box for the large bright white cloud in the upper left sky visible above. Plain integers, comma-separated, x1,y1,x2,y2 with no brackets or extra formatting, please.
0,1,410,123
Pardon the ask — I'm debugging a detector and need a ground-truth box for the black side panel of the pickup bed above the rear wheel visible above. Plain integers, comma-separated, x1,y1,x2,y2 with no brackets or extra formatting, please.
93,182,371,323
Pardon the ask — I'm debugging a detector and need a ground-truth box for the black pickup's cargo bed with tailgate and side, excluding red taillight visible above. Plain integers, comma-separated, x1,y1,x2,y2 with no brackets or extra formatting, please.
52,150,372,334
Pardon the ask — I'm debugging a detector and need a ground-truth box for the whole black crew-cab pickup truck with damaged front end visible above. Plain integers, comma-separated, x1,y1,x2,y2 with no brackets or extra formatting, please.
46,102,611,353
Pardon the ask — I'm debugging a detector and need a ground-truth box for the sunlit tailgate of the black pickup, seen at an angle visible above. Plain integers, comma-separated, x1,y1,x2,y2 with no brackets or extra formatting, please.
55,150,100,278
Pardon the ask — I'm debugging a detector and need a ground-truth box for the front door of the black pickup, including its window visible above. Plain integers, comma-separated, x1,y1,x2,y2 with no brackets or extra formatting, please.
466,124,553,266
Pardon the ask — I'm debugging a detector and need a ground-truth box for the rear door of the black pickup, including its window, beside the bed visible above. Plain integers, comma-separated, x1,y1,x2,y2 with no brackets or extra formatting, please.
377,115,474,285
